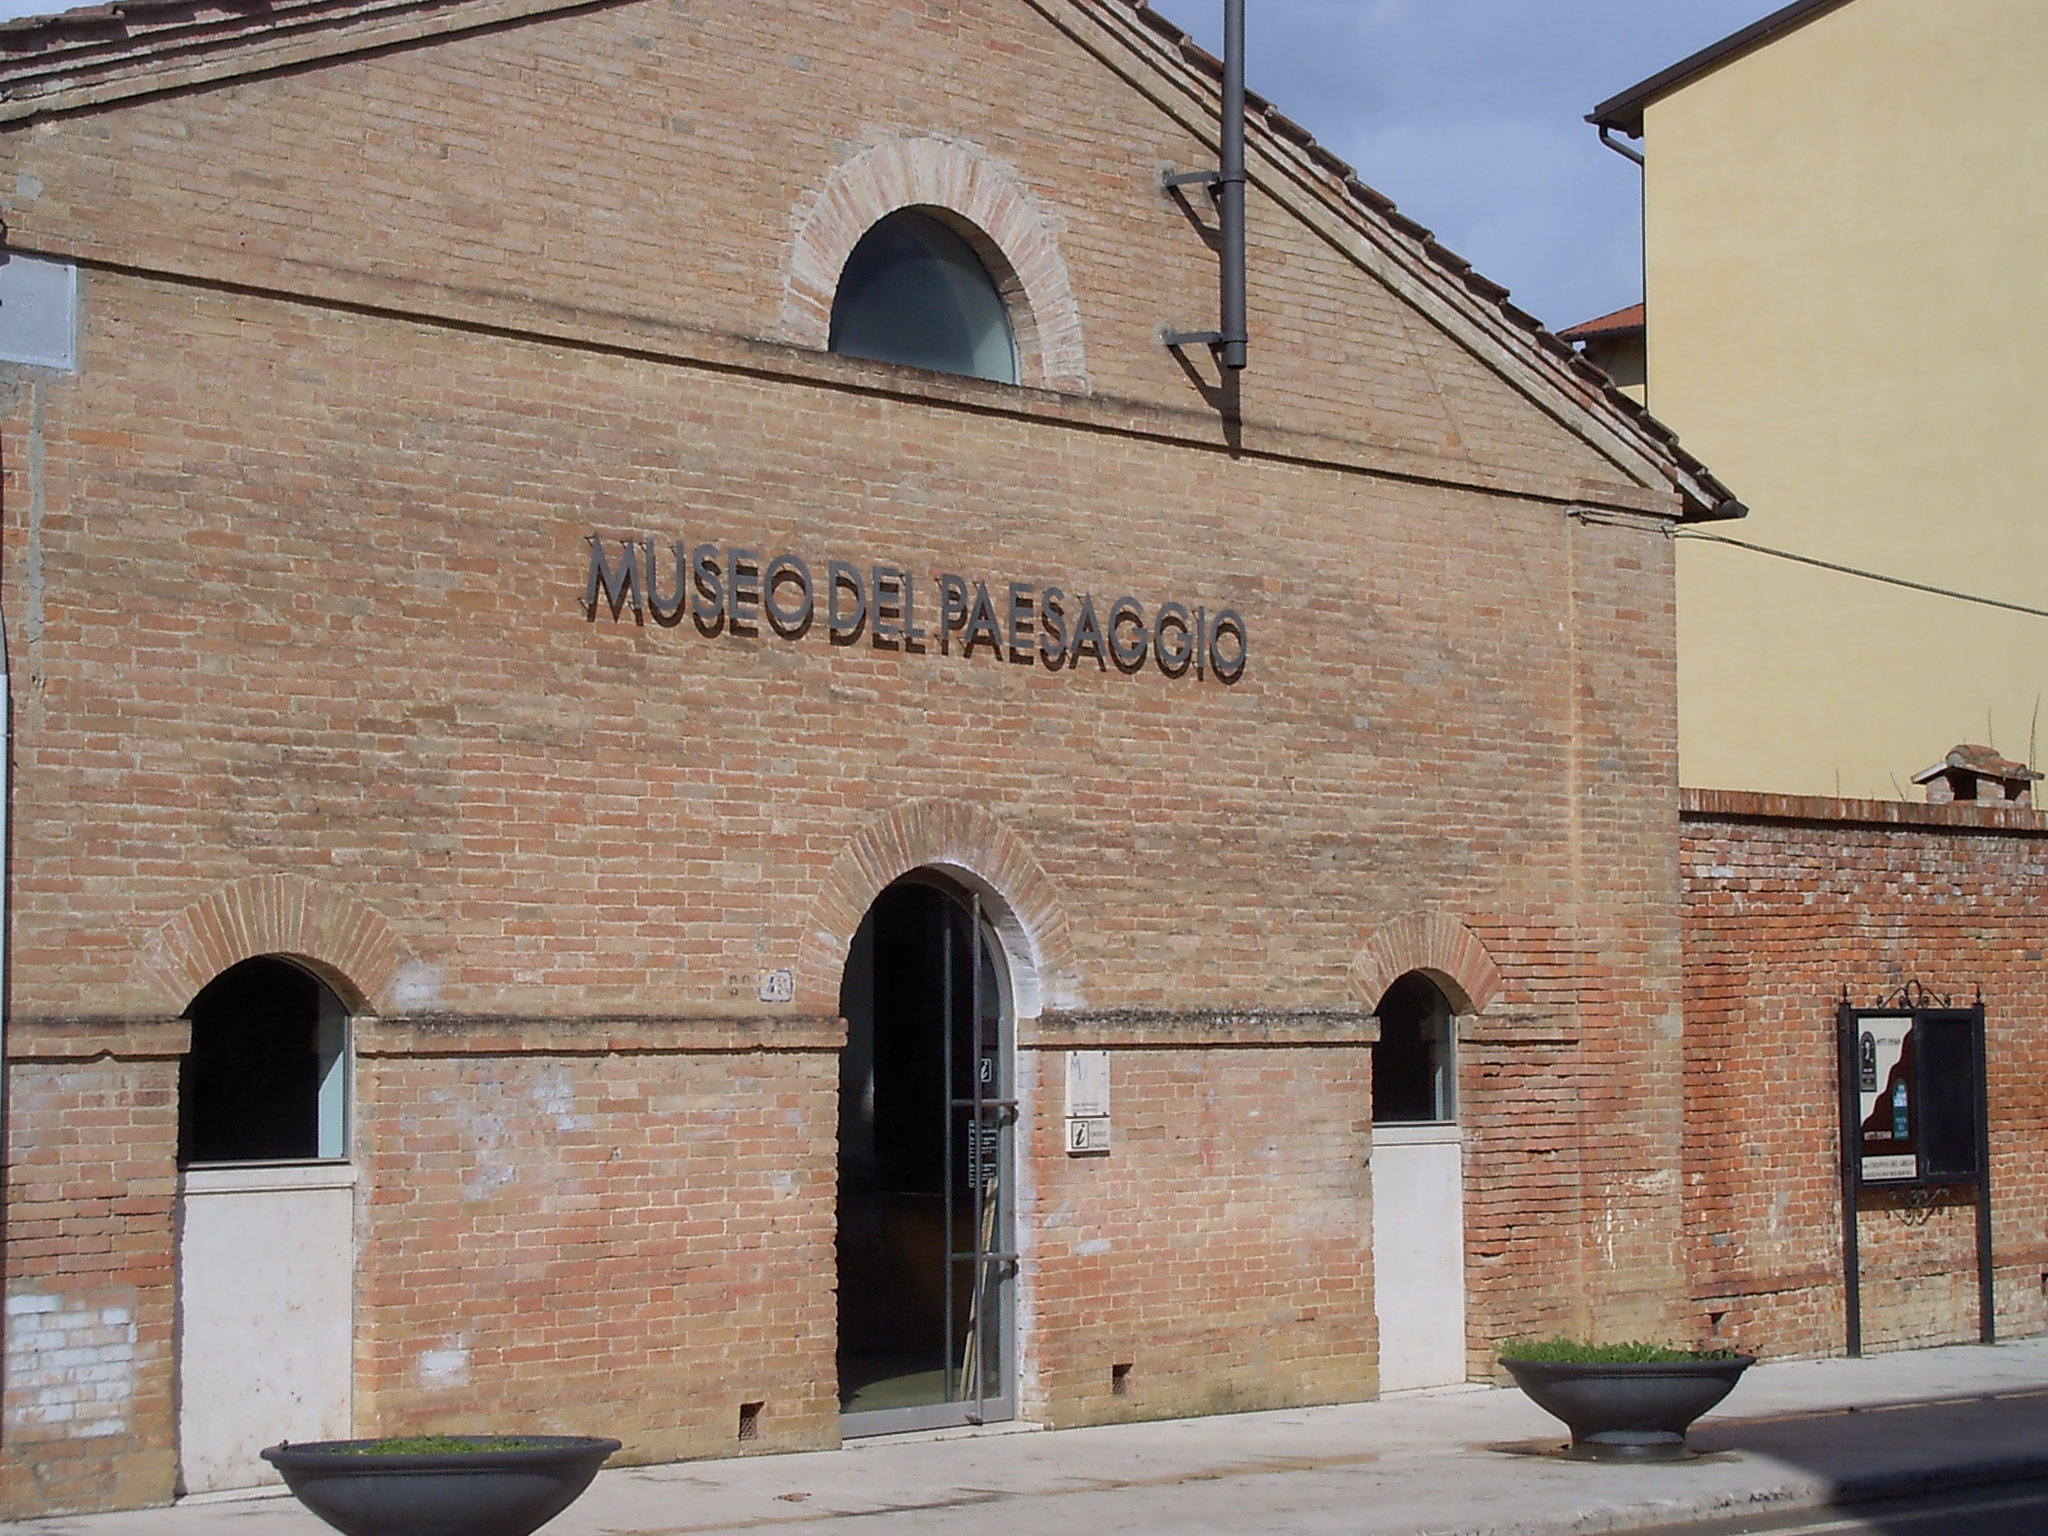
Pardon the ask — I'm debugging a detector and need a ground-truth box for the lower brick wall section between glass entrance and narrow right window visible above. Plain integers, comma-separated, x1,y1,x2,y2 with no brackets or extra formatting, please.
1024,1040,1378,1425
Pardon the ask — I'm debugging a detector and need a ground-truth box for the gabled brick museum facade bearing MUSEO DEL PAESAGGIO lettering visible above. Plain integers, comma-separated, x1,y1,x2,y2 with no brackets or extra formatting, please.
0,0,1875,1513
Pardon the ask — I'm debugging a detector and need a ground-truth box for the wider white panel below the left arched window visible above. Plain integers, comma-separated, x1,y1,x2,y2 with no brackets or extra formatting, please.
178,1163,356,1493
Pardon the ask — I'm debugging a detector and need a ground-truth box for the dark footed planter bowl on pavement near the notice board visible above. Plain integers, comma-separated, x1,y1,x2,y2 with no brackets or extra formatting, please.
1501,1354,1757,1462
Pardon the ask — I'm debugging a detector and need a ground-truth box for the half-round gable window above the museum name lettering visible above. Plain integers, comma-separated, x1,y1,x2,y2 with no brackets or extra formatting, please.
829,209,1018,383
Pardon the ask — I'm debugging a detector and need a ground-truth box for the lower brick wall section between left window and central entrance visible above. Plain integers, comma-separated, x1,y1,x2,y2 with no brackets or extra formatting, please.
356,1026,838,1460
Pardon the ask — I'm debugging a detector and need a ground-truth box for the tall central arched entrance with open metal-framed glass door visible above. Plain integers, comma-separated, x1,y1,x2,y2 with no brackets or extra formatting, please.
838,870,1016,1436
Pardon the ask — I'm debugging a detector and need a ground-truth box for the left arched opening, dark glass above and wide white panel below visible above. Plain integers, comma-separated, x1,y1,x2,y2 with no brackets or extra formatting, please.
178,956,354,1493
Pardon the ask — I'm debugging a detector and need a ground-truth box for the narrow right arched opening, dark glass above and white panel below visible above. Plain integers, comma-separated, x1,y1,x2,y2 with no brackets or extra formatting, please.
1372,971,1466,1393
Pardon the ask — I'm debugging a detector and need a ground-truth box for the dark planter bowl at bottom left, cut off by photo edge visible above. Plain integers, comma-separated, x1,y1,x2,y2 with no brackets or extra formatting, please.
262,1436,618,1536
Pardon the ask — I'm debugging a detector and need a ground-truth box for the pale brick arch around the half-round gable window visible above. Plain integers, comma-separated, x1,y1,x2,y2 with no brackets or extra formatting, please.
780,137,1087,395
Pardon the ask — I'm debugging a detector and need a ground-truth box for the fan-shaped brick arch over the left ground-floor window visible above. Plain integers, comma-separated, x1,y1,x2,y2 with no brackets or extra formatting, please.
135,874,412,1014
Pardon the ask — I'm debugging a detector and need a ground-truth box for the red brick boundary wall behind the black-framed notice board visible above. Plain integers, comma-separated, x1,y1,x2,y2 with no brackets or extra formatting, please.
1683,791,2048,1354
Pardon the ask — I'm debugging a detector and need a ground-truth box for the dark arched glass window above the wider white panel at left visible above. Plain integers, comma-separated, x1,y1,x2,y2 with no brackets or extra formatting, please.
178,956,348,1165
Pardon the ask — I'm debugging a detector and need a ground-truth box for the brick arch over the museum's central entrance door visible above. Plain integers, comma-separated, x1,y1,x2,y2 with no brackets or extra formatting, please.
797,799,1079,1018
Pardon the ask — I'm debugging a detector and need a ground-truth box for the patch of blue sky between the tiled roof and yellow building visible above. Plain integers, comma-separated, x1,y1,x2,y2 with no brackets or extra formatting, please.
1153,0,1784,330
